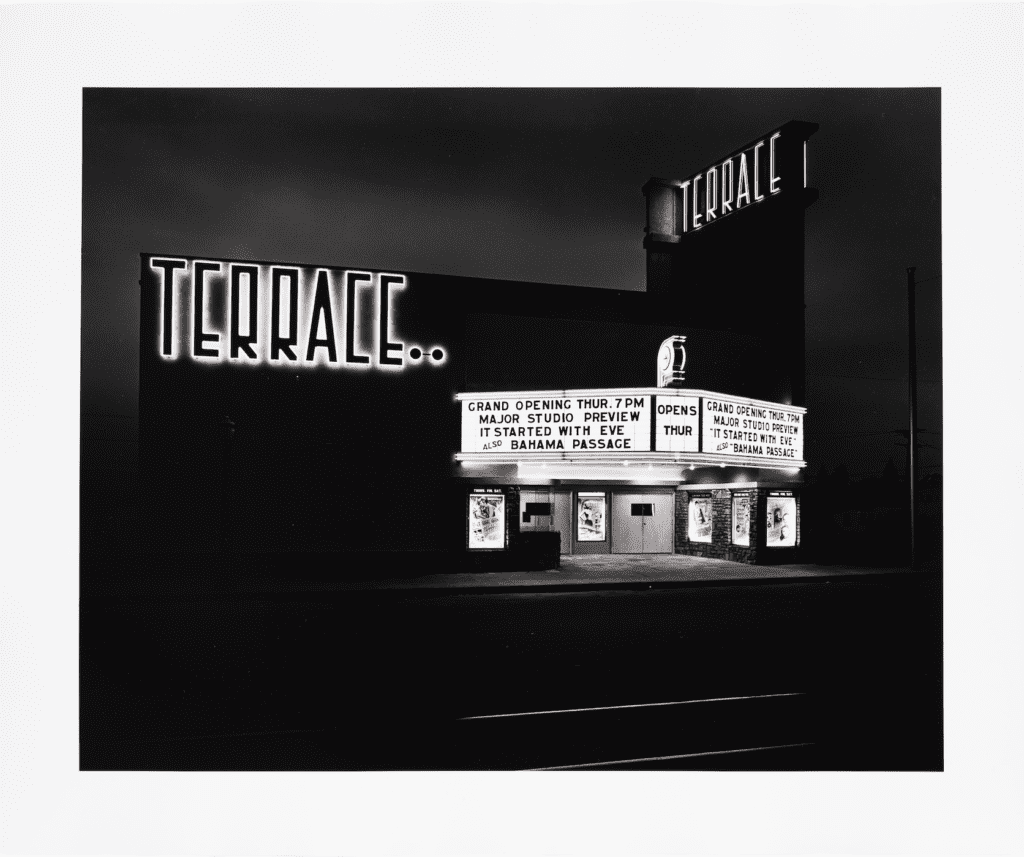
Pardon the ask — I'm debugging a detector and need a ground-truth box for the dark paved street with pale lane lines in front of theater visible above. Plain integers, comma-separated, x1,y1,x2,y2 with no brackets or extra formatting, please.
82,572,942,770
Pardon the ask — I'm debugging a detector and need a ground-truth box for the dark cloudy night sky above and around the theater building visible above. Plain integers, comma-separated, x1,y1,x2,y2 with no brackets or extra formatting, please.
82,89,942,476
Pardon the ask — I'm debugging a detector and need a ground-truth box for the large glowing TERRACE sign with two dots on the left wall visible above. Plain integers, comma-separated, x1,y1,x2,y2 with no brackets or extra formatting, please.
148,256,447,371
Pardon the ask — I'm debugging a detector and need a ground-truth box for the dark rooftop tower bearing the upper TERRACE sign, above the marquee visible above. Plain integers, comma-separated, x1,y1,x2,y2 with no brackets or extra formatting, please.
643,122,818,405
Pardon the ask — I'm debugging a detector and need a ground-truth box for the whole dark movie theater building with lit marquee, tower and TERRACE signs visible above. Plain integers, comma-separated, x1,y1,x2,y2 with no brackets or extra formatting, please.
139,122,816,573
